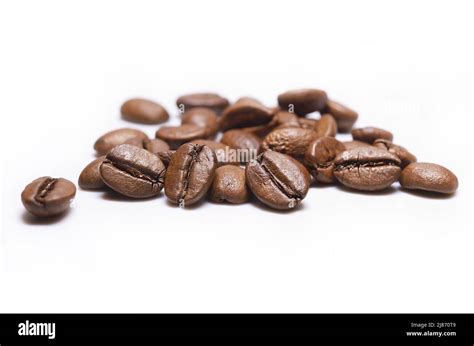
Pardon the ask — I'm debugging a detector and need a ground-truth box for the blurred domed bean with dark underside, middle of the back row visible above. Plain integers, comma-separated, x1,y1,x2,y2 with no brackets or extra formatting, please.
220,97,273,131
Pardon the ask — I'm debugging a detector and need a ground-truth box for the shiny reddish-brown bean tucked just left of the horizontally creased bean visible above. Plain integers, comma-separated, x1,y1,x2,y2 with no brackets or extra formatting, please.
305,137,346,183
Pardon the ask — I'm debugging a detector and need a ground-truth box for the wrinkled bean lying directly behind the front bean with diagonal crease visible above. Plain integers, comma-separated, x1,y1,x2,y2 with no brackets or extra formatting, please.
261,127,318,160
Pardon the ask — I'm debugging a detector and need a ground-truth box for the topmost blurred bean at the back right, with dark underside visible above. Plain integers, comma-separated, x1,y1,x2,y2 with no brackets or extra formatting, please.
278,89,328,116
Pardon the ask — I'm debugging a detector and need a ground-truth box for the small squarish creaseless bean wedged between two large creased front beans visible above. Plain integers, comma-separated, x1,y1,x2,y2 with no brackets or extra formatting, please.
209,165,250,204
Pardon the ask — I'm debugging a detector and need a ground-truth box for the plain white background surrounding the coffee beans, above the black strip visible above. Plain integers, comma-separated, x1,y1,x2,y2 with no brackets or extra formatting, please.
0,0,474,312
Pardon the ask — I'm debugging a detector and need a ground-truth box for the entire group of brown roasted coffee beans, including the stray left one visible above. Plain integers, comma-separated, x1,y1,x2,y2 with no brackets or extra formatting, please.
21,89,458,217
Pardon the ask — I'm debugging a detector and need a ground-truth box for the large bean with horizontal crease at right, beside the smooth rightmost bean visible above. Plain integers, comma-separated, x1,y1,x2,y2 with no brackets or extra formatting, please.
334,146,400,191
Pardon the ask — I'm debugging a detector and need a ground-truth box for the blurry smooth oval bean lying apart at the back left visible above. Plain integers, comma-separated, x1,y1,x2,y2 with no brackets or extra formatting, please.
120,98,169,124
